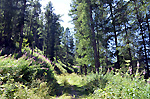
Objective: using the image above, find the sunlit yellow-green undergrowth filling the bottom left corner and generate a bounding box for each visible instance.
[0,80,51,99]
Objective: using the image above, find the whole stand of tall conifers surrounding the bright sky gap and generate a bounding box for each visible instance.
[0,0,150,74]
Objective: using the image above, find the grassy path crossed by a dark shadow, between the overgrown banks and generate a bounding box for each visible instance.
[55,74,88,99]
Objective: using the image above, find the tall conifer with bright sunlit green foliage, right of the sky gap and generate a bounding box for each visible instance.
[70,0,100,72]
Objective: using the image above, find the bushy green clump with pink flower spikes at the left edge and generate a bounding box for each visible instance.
[0,56,34,84]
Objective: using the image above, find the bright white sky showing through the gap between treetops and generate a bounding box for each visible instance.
[40,0,73,31]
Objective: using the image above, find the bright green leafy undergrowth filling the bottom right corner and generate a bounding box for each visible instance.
[89,72,150,99]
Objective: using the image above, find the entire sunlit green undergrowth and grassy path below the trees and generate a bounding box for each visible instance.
[0,49,150,99]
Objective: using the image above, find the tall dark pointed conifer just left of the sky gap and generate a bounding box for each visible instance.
[45,2,60,61]
